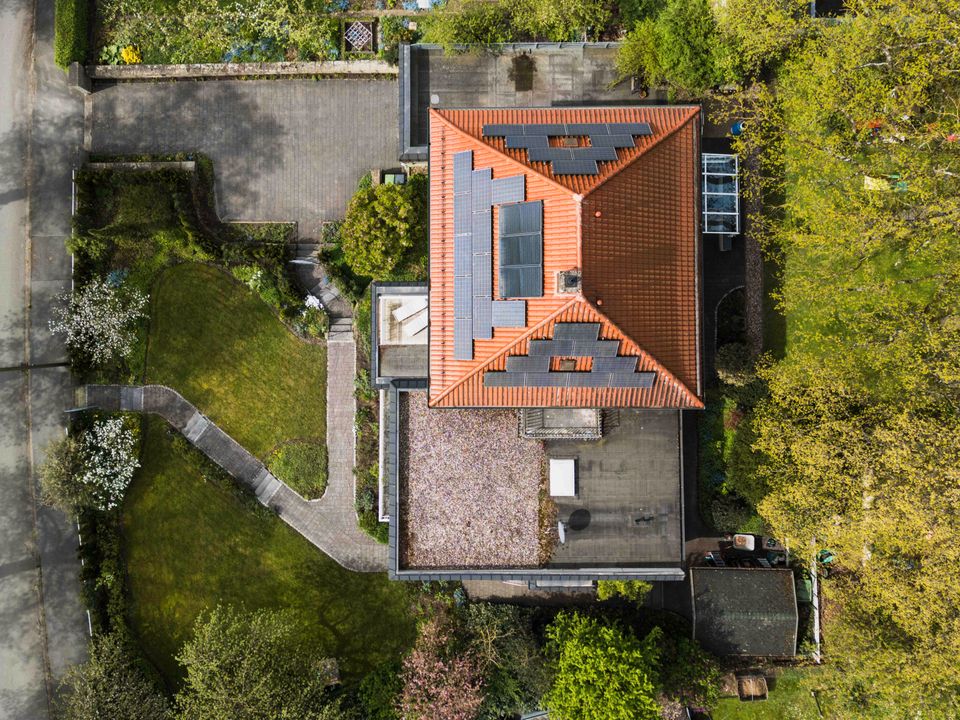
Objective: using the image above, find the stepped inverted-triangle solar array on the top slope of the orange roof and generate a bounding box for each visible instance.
[483,123,653,175]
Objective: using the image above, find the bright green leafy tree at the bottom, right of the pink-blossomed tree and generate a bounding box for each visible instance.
[544,612,660,720]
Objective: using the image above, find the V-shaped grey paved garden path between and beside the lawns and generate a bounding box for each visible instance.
[80,386,387,572]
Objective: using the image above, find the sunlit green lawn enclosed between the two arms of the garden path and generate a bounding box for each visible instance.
[147,263,327,460]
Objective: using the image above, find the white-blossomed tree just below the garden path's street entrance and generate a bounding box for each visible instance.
[77,418,140,510]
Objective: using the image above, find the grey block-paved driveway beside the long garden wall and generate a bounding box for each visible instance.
[88,79,399,237]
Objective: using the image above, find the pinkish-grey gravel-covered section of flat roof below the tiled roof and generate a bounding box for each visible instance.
[400,393,544,568]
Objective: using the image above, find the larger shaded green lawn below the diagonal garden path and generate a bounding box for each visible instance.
[123,418,414,686]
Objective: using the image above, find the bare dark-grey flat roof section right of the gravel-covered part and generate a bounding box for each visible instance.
[545,409,683,567]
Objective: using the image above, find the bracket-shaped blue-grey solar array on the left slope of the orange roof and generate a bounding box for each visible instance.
[453,150,542,360]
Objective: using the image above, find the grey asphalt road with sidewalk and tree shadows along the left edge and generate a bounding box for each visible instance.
[0,0,87,720]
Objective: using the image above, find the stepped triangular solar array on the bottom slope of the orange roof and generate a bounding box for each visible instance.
[483,323,657,388]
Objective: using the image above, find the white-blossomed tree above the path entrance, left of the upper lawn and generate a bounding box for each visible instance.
[50,278,147,365]
